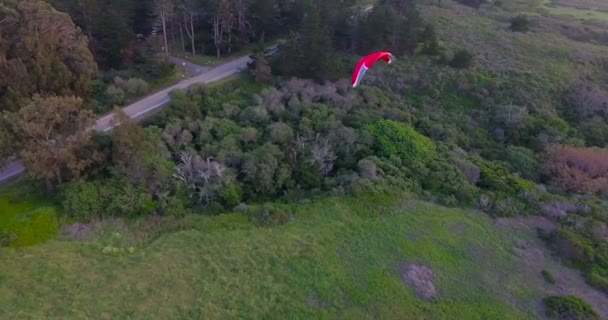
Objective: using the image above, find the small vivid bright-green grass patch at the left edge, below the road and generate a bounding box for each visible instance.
[0,181,59,247]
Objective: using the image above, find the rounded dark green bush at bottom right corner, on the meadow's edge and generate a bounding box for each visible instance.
[543,296,600,320]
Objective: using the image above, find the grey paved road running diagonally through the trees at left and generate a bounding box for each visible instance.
[0,45,276,184]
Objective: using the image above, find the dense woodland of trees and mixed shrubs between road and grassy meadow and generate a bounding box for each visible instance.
[0,0,608,316]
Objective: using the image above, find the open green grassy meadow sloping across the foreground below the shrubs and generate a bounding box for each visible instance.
[0,192,542,320]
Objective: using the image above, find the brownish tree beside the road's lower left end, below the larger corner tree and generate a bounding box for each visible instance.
[3,95,99,191]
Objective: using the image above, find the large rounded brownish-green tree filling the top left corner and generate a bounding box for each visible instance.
[0,0,97,111]
